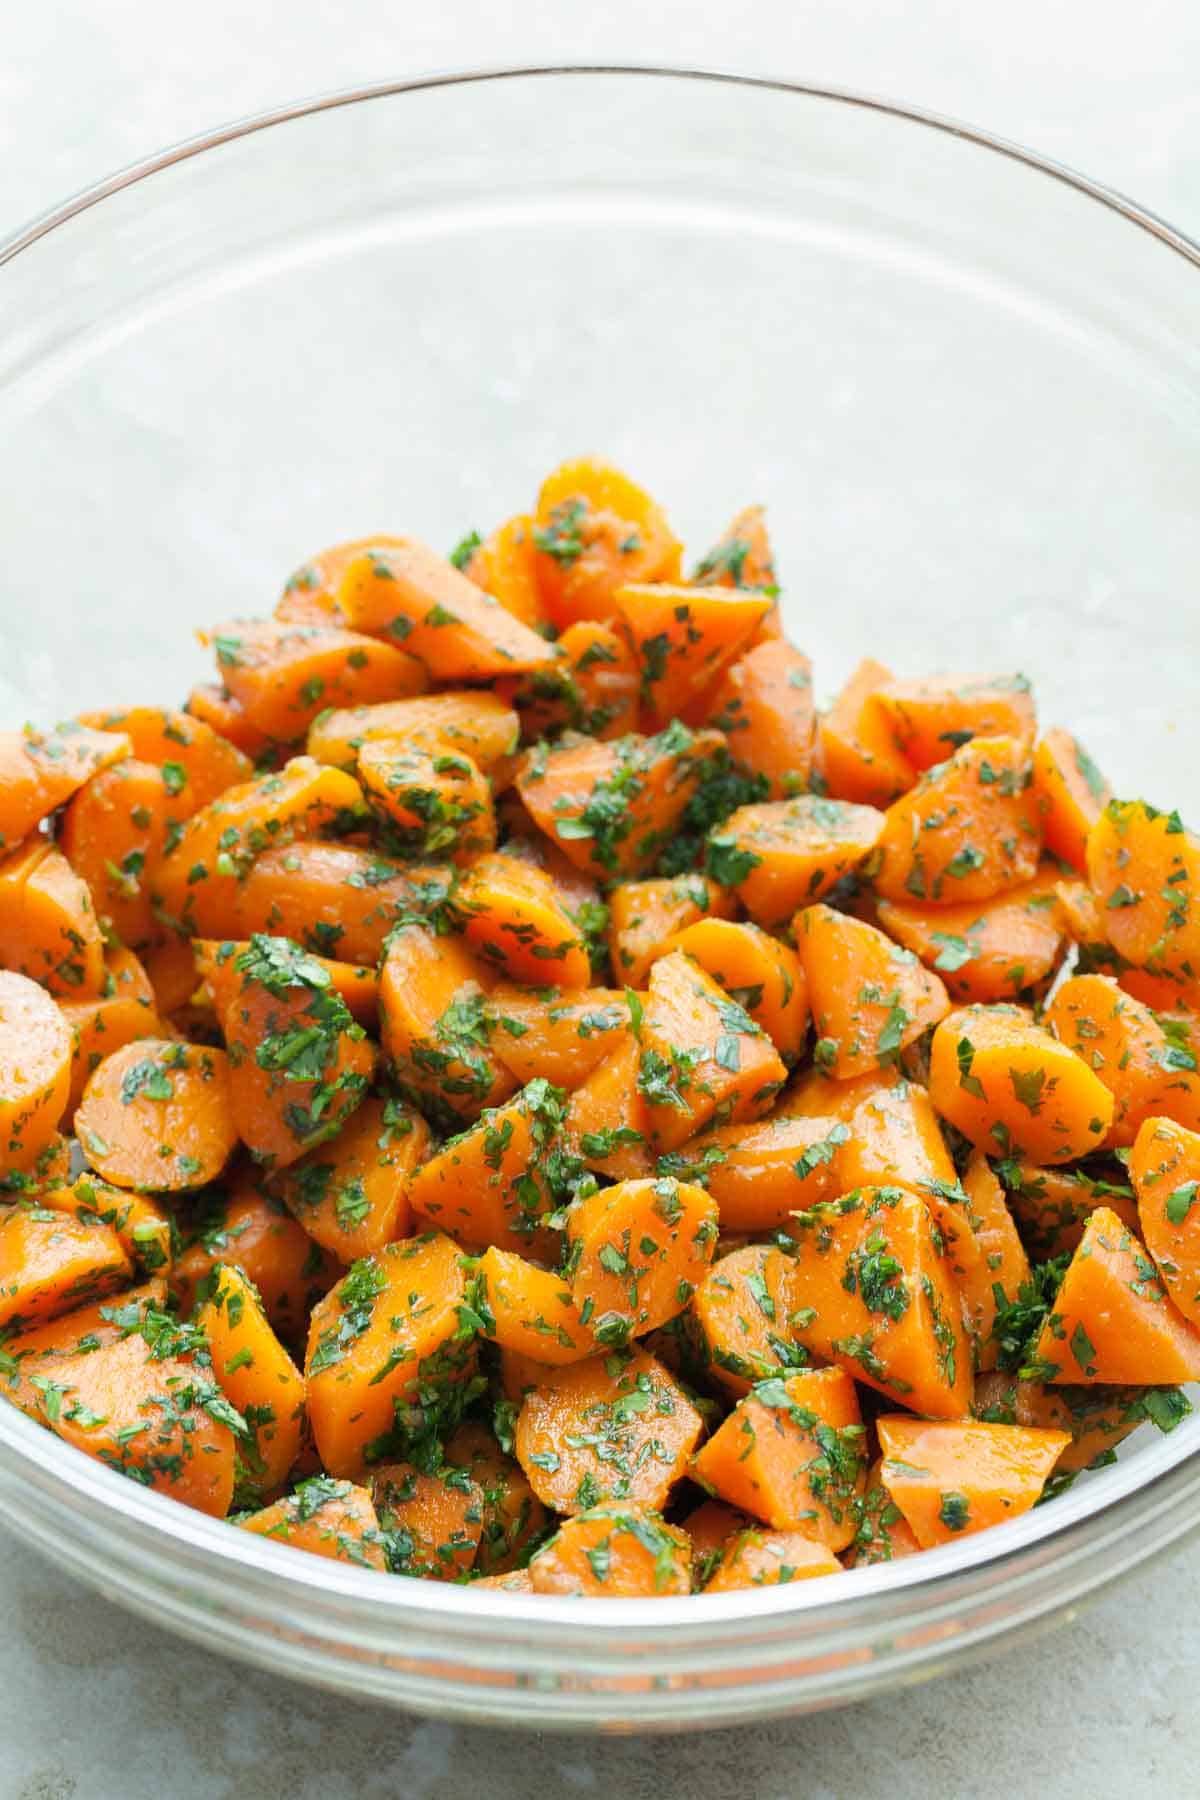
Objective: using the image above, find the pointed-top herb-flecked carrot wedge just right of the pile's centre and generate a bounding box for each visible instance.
[637,950,788,1150]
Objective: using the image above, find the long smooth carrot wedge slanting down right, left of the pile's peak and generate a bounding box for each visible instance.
[338,538,554,676]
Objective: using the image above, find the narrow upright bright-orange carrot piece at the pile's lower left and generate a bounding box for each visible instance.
[196,1264,304,1494]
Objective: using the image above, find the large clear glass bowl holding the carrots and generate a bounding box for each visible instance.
[0,68,1200,1730]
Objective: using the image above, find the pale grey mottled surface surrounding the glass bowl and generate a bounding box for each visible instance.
[0,0,1200,1800]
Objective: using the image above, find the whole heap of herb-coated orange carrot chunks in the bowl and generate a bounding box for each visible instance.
[0,461,1200,1597]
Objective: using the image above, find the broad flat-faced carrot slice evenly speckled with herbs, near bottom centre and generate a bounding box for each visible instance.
[516,1348,702,1514]
